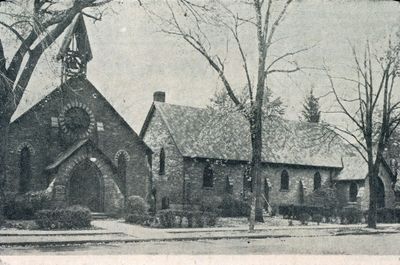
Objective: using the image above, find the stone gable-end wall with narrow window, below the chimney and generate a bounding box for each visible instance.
[143,109,184,209]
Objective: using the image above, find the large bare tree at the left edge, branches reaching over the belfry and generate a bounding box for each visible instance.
[0,0,112,206]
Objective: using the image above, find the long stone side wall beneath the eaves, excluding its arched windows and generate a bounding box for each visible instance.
[181,159,331,206]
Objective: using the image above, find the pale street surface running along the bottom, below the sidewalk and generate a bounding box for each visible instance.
[0,234,400,255]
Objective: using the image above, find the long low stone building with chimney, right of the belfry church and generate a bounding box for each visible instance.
[140,92,396,210]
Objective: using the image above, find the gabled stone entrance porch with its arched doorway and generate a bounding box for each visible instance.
[47,140,124,214]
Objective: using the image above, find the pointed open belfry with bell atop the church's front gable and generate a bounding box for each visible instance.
[57,14,93,83]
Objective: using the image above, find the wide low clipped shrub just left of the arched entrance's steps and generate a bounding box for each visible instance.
[35,205,91,229]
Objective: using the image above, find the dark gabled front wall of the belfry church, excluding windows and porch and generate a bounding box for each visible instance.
[7,79,150,203]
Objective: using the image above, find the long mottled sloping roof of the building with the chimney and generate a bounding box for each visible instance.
[140,102,344,168]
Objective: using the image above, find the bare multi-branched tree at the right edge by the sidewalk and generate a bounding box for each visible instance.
[326,41,400,228]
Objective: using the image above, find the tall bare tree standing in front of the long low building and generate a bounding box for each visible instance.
[149,0,310,231]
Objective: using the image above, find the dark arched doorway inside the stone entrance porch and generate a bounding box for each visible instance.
[68,160,104,212]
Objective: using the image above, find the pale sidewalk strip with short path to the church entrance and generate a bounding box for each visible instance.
[0,219,400,246]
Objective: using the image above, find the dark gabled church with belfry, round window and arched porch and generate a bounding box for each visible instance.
[6,15,152,213]
